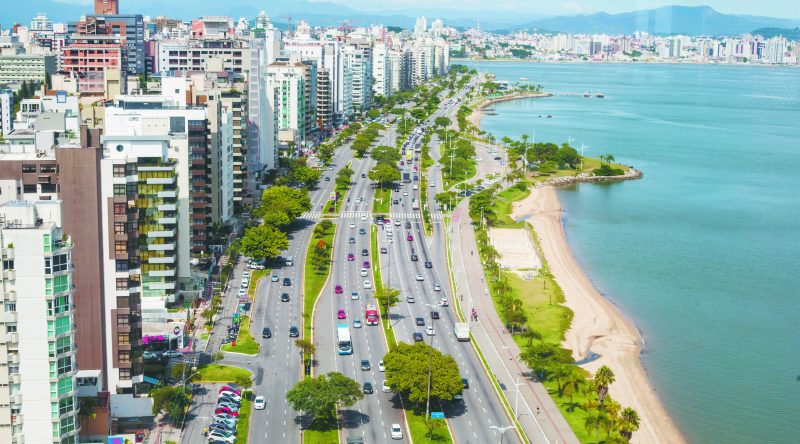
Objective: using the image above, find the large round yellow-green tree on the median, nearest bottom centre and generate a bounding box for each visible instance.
[383,342,464,405]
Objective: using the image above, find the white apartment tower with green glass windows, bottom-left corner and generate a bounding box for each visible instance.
[0,200,80,444]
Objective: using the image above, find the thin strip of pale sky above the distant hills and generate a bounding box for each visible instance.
[306,0,800,19]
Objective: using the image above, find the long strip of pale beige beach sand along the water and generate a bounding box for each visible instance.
[512,186,686,444]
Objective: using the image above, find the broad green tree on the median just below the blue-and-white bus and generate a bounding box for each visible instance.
[286,372,364,422]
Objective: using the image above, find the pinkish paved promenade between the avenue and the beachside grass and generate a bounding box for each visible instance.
[450,199,579,444]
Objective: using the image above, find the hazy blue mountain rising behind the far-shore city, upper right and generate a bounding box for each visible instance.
[518,6,800,35]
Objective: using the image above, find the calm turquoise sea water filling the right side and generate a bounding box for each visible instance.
[467,62,800,443]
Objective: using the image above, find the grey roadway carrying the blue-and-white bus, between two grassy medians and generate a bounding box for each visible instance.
[313,123,405,443]
